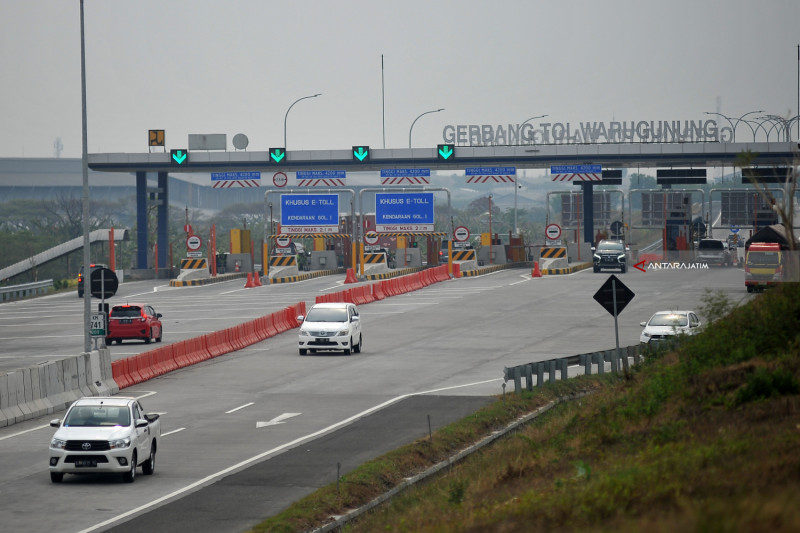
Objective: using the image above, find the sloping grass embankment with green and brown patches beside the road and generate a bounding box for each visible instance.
[254,284,800,532]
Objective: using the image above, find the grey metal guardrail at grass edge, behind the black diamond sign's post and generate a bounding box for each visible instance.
[503,344,641,392]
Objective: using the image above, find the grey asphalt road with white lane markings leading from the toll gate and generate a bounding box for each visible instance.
[0,268,752,532]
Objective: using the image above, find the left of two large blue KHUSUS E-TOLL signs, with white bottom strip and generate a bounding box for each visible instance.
[281,194,339,234]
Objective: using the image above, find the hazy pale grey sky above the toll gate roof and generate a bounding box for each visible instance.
[0,0,800,157]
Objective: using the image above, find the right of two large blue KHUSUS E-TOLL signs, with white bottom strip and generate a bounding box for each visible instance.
[375,192,434,232]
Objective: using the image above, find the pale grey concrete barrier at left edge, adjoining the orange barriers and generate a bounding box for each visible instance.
[0,348,119,426]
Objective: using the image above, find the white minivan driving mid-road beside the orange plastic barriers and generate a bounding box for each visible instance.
[297,302,362,355]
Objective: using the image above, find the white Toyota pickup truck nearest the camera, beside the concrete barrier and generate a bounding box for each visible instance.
[49,396,161,483]
